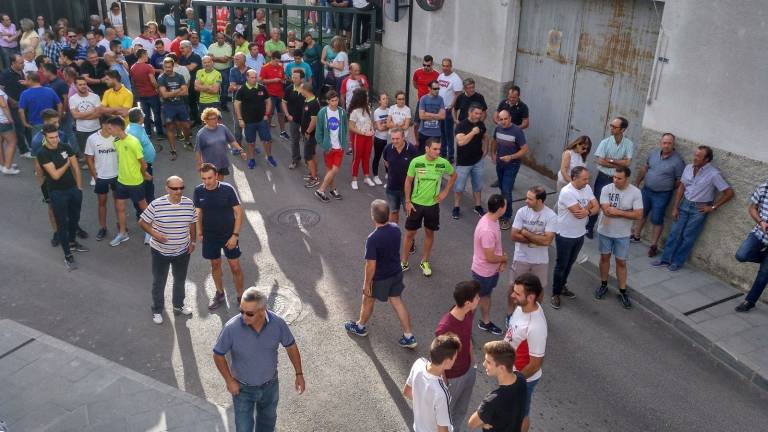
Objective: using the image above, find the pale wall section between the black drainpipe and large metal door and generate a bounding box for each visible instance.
[383,0,520,82]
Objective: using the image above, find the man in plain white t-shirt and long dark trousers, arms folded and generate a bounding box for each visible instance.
[550,166,600,309]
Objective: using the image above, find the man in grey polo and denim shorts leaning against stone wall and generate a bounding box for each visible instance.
[631,133,685,258]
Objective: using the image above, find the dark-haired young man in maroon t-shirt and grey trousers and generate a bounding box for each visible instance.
[435,281,480,431]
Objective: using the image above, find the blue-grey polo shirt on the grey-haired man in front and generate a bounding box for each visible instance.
[213,310,296,386]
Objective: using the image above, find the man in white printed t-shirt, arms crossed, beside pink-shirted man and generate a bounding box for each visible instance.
[507,186,557,319]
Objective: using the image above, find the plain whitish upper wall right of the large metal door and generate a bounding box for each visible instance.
[643,0,768,162]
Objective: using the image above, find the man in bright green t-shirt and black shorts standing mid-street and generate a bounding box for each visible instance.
[400,138,456,277]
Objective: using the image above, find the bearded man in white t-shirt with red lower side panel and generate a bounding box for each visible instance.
[504,273,547,432]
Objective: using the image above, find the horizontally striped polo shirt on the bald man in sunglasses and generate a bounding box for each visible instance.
[141,195,197,256]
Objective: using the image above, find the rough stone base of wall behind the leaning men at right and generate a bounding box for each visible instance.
[633,128,768,299]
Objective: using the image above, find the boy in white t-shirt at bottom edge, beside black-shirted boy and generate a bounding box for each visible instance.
[403,334,461,432]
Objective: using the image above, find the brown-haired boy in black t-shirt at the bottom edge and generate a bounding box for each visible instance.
[469,340,528,432]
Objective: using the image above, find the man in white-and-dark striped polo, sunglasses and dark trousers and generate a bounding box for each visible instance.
[139,176,197,324]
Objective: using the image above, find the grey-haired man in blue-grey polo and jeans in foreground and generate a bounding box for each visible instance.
[213,287,304,432]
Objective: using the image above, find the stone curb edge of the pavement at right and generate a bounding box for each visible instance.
[582,260,768,393]
